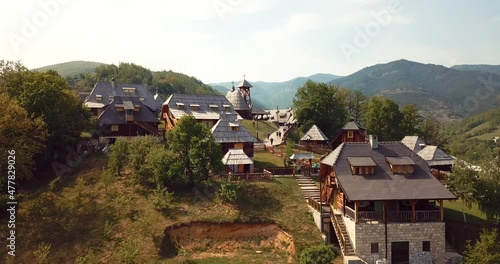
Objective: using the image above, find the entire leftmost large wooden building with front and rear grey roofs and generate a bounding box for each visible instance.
[84,81,161,140]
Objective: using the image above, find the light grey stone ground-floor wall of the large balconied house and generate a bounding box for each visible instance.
[353,222,445,264]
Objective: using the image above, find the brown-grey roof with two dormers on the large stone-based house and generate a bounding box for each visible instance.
[321,142,456,201]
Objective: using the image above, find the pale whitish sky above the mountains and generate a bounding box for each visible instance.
[0,0,500,83]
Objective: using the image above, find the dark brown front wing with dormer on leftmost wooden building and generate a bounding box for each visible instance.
[97,96,160,139]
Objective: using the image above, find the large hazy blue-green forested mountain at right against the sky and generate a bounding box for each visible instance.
[331,60,500,120]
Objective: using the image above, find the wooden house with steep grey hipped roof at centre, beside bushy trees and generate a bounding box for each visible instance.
[211,114,257,173]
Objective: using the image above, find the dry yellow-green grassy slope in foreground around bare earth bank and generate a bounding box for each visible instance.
[4,156,332,263]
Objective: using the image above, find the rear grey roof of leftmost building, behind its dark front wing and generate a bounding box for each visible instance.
[85,82,161,111]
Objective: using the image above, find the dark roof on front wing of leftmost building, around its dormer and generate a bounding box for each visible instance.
[98,96,160,126]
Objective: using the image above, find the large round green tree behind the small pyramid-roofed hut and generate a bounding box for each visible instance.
[293,80,347,138]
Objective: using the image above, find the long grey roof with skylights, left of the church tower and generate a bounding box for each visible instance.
[163,94,242,120]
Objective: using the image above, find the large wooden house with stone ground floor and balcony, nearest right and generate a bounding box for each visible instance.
[320,137,456,264]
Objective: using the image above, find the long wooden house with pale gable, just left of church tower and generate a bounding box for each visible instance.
[161,94,241,131]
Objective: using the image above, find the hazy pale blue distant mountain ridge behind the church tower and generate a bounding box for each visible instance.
[209,73,340,109]
